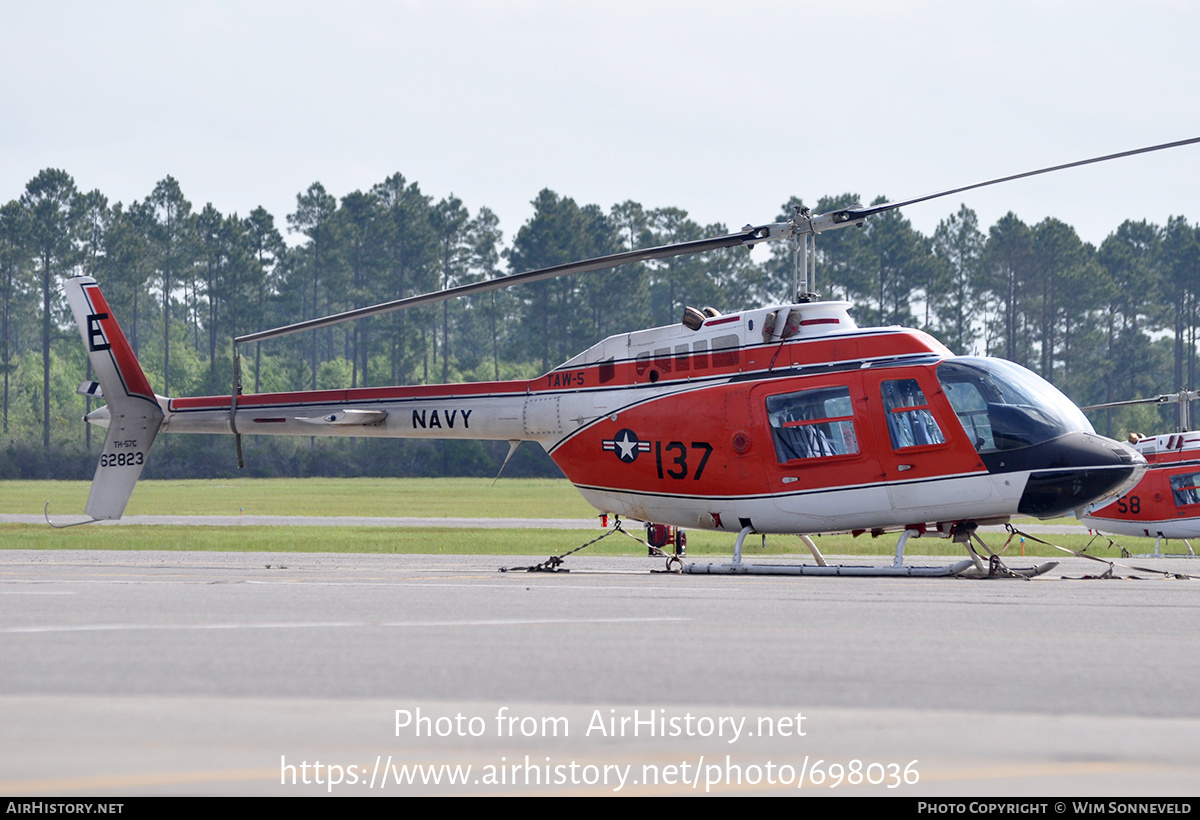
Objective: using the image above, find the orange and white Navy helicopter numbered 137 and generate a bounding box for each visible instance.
[56,138,1200,574]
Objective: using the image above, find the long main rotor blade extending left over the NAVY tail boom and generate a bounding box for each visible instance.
[233,225,772,345]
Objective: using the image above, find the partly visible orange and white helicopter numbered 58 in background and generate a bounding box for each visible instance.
[1080,390,1200,557]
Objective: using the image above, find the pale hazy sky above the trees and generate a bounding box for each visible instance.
[0,0,1200,256]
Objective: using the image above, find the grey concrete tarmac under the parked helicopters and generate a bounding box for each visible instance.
[0,550,1200,797]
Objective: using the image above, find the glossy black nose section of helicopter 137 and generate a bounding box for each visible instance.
[982,432,1146,519]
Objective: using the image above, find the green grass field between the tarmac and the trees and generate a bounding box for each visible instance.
[0,478,1113,557]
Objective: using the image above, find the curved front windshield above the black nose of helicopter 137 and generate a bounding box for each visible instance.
[937,357,1094,453]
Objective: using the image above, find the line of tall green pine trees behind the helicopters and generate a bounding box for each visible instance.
[0,168,1200,477]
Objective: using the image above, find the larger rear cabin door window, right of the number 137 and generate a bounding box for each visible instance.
[767,387,858,463]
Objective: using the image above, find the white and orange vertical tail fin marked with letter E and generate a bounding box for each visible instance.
[62,276,163,520]
